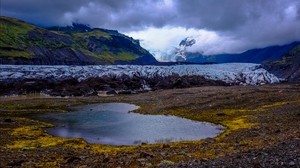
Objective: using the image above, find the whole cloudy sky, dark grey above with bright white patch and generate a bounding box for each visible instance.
[0,0,300,61]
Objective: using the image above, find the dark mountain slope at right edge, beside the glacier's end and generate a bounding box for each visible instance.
[263,45,300,82]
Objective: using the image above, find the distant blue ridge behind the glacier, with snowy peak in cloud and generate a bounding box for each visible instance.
[175,37,300,64]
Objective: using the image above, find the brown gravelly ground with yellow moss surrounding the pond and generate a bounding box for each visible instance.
[0,84,300,167]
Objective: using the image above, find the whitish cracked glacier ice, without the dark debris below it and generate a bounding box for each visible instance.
[0,63,280,85]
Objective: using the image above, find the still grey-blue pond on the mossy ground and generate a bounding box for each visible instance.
[36,103,222,145]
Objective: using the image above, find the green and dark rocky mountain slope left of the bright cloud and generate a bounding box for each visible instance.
[0,16,157,65]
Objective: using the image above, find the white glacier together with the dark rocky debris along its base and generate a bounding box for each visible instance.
[0,63,280,96]
